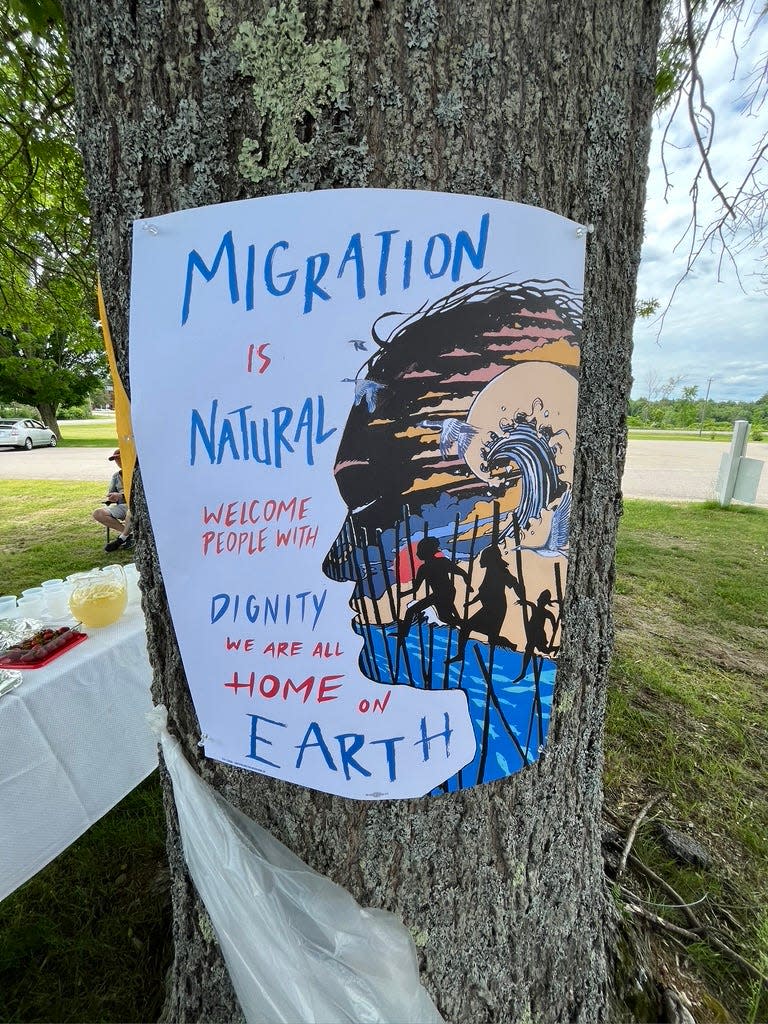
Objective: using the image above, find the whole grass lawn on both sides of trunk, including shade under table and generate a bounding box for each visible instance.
[0,481,768,1024]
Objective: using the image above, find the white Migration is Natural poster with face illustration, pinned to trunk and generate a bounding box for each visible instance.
[130,189,585,800]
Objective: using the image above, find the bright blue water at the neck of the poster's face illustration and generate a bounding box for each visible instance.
[354,621,557,796]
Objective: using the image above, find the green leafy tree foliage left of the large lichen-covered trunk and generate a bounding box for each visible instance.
[0,0,105,433]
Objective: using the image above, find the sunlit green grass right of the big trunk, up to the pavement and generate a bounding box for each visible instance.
[605,502,768,1024]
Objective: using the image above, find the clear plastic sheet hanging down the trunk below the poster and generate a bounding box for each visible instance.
[147,707,442,1024]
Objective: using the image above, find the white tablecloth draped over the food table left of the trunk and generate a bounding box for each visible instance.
[0,604,158,899]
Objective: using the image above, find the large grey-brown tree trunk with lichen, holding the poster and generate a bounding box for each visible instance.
[65,0,662,1024]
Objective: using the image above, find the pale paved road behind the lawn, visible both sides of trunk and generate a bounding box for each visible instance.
[0,440,768,508]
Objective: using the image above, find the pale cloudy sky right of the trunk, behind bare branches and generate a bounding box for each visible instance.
[632,12,768,401]
